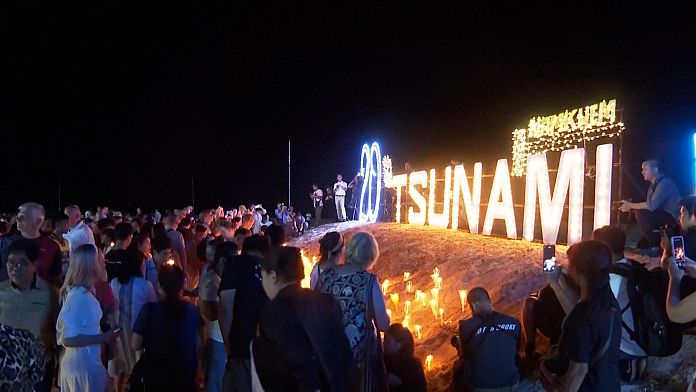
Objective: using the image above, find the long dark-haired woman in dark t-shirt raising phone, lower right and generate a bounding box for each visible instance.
[541,241,621,391]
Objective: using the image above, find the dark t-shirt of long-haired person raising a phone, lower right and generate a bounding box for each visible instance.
[558,284,621,391]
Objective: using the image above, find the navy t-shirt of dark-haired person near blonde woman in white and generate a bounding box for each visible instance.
[133,301,200,391]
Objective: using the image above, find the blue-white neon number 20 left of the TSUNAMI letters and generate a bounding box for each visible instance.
[358,142,382,223]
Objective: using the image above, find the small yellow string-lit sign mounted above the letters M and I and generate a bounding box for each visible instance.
[511,99,625,177]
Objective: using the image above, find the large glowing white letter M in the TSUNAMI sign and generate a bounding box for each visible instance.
[523,148,585,245]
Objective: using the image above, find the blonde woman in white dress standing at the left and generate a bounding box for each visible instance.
[56,244,119,392]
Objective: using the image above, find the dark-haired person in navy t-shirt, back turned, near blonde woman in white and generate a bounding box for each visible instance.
[131,265,200,391]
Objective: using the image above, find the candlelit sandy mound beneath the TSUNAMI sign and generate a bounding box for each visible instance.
[289,222,696,391]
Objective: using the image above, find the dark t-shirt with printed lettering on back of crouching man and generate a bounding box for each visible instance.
[459,312,521,388]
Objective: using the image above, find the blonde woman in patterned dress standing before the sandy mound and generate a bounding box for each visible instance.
[320,232,390,391]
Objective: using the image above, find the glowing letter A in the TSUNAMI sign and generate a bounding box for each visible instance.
[482,159,517,238]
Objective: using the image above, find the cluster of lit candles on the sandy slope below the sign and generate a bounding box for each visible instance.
[382,267,467,370]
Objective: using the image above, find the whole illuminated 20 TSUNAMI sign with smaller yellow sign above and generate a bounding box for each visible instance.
[368,100,624,245]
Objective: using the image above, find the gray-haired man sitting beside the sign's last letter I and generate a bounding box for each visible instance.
[620,159,681,256]
